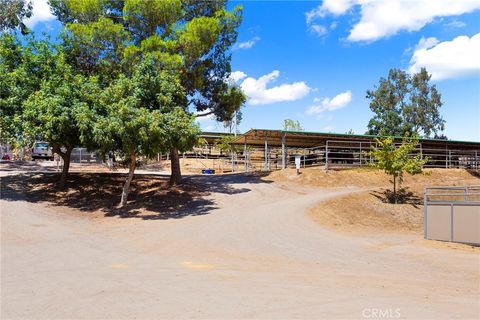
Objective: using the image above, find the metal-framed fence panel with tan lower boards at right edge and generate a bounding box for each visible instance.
[424,186,480,245]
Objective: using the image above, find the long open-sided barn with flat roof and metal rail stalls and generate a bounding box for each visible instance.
[193,129,480,171]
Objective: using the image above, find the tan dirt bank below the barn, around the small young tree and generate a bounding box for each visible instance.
[269,168,480,233]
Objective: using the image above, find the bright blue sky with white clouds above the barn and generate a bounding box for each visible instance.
[30,0,480,141]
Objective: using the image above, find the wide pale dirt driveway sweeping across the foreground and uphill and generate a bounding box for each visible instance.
[0,177,480,319]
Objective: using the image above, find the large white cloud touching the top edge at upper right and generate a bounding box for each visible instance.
[306,0,480,42]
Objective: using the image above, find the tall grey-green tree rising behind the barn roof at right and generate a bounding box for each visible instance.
[366,68,445,137]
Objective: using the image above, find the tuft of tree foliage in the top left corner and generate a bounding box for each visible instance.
[0,0,33,35]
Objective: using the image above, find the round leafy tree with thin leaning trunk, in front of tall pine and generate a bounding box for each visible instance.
[80,59,200,207]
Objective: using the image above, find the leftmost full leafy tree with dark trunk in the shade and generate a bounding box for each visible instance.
[22,53,99,188]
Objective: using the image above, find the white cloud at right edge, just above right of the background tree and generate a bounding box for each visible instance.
[408,33,480,80]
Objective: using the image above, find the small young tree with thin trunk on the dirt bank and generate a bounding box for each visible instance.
[369,136,428,203]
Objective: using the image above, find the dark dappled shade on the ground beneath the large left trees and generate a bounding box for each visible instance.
[0,172,270,220]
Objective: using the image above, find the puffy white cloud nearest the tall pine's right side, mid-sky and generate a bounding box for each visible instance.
[240,70,311,105]
